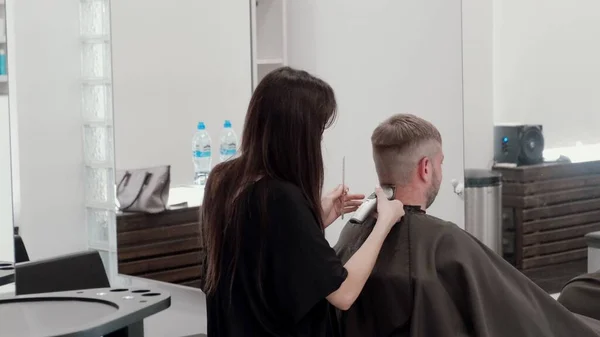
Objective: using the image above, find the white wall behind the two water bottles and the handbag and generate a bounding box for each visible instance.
[111,0,252,185]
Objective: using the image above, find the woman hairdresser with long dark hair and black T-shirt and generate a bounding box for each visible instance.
[202,67,404,337]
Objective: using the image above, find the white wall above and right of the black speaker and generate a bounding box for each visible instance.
[494,0,600,148]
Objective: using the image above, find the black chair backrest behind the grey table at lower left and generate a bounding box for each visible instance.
[15,250,110,295]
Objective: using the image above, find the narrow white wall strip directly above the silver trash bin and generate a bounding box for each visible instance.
[462,0,494,169]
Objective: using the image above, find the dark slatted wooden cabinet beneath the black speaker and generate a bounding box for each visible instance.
[494,161,600,292]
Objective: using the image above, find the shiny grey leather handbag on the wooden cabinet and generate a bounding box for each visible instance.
[116,165,171,214]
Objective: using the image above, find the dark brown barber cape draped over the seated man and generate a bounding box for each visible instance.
[335,207,600,337]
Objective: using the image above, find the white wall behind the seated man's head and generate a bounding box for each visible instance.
[288,0,464,243]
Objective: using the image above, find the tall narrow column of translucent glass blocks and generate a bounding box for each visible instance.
[79,0,117,283]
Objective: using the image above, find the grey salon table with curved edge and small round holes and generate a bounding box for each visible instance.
[0,288,171,337]
